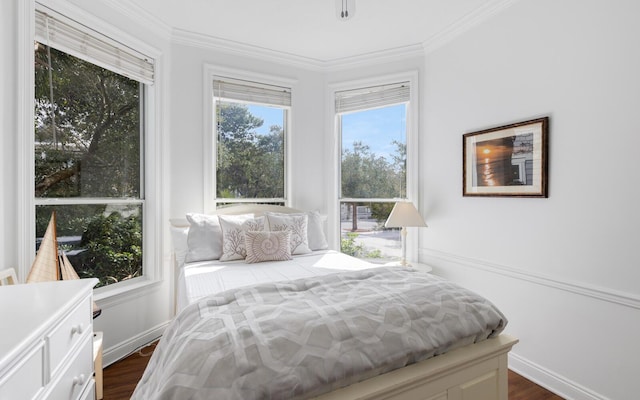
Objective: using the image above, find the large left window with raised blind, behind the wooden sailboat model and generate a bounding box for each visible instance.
[33,7,154,286]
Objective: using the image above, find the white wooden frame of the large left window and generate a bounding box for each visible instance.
[17,0,163,304]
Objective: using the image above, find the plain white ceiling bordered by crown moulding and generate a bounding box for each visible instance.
[111,0,514,63]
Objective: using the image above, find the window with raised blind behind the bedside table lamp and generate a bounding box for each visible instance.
[335,82,410,263]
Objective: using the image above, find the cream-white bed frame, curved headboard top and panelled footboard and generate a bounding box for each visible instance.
[171,204,518,400]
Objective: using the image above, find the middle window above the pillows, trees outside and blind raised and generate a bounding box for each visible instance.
[213,77,291,206]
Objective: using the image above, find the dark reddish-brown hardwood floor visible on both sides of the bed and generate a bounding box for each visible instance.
[104,344,562,400]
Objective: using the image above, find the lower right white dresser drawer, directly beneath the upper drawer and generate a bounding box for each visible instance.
[47,335,94,400]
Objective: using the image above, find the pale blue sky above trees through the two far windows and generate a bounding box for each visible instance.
[248,104,407,162]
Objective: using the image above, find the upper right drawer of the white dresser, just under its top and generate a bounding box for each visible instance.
[47,298,92,377]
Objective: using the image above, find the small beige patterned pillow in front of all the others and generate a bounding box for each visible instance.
[244,231,291,263]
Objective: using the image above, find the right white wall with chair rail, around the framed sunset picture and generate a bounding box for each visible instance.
[421,0,640,399]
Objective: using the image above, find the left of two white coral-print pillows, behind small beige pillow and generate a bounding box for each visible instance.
[218,214,265,261]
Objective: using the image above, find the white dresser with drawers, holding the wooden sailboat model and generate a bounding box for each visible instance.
[0,279,98,400]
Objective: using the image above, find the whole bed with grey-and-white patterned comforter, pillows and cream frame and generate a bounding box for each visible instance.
[132,205,517,400]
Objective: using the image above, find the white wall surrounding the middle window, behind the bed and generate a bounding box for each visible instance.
[170,42,326,218]
